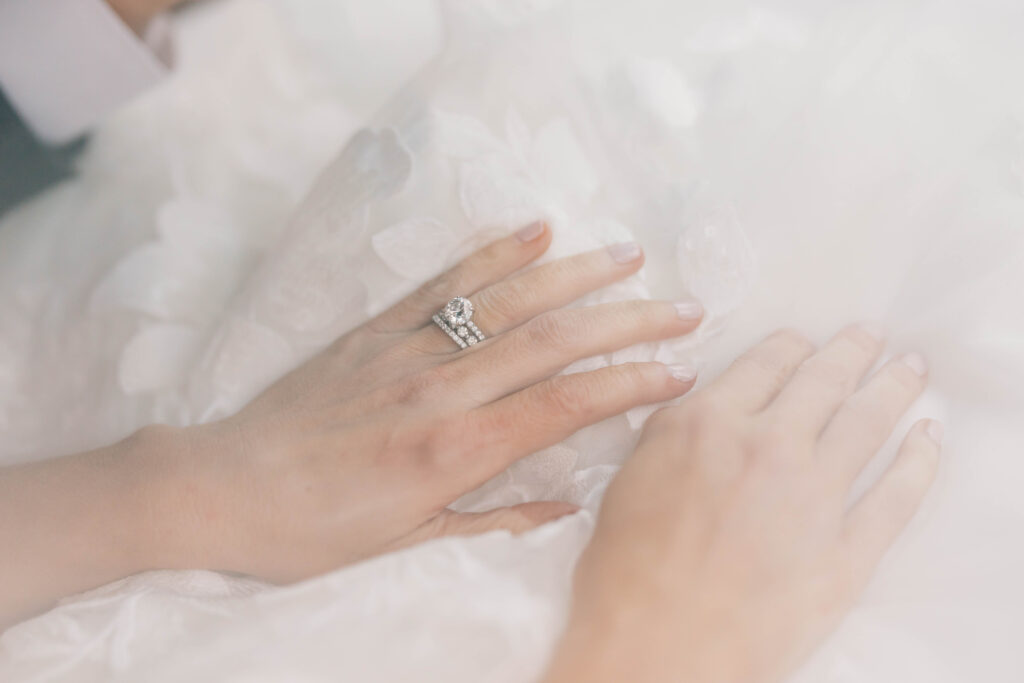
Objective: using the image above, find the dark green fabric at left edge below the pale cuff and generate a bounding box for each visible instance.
[0,90,84,215]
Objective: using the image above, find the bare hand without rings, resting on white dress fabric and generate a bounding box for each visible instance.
[548,328,941,683]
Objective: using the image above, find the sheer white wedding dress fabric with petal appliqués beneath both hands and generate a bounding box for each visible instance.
[0,0,1024,683]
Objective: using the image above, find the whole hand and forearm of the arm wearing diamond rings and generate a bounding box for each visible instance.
[0,223,701,624]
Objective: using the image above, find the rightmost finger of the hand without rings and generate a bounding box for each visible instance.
[846,420,942,581]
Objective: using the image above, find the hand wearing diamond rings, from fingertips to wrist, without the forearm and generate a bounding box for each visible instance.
[152,224,701,581]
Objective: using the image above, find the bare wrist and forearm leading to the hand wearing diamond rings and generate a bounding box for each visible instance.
[0,428,197,629]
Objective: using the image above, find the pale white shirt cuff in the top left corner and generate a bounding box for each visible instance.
[0,0,169,144]
